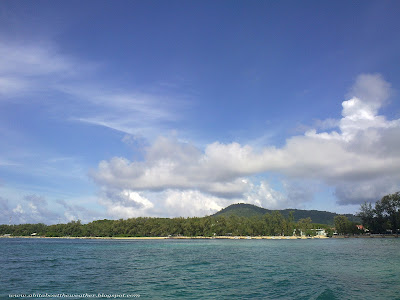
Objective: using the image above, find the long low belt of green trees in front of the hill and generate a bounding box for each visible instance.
[0,211,332,237]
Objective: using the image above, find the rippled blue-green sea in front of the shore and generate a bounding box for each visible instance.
[0,238,400,299]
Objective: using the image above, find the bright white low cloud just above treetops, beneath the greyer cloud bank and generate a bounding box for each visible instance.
[99,181,290,218]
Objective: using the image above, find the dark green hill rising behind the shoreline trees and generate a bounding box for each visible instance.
[212,203,361,225]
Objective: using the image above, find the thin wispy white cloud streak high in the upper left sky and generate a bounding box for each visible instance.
[0,39,188,138]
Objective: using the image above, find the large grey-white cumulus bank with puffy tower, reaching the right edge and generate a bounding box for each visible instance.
[91,74,400,217]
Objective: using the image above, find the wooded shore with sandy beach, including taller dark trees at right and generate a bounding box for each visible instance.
[0,192,400,239]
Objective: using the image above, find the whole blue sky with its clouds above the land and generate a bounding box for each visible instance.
[0,0,400,224]
